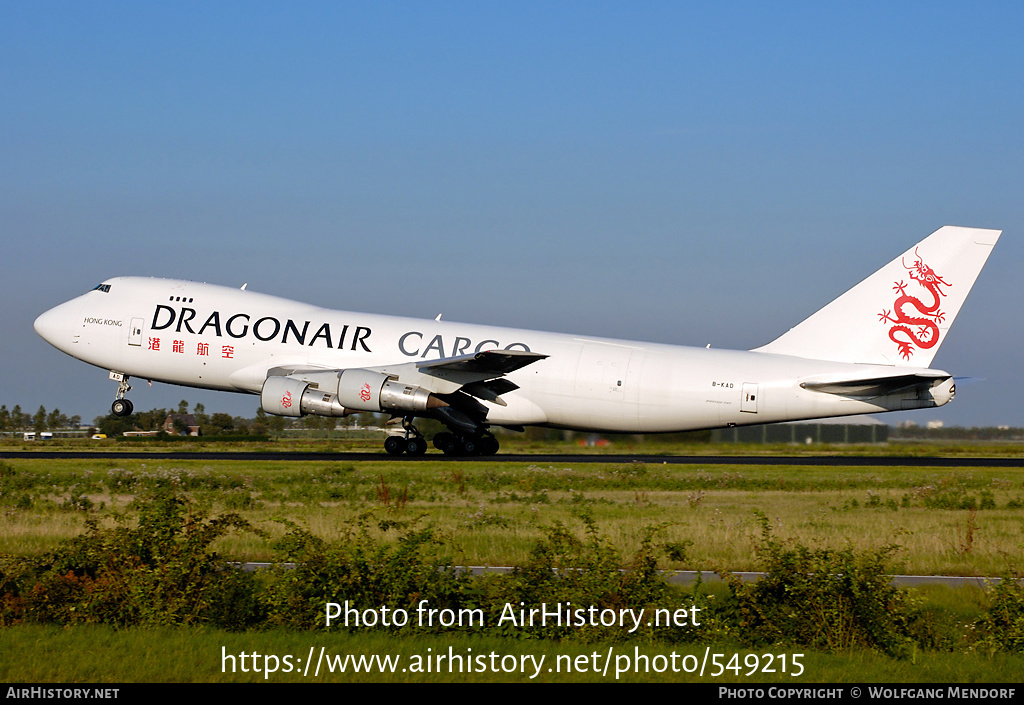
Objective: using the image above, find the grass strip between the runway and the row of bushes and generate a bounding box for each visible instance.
[0,448,1024,576]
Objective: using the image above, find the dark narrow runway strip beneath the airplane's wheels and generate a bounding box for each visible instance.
[0,451,1024,467]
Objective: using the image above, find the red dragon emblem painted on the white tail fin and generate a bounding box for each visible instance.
[879,248,950,360]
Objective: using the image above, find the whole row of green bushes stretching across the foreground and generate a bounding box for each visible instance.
[12,489,1024,657]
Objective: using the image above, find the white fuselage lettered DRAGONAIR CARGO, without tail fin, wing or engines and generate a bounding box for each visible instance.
[36,277,952,432]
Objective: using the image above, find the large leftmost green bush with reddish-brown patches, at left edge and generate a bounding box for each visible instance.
[0,489,261,629]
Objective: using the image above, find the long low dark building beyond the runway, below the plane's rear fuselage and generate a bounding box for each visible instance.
[711,416,889,444]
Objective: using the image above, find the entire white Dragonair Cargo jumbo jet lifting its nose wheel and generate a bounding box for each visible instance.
[35,226,1000,455]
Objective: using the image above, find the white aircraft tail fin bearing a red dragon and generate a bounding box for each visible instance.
[755,225,1001,368]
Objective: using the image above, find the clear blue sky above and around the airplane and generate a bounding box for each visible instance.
[0,1,1024,426]
